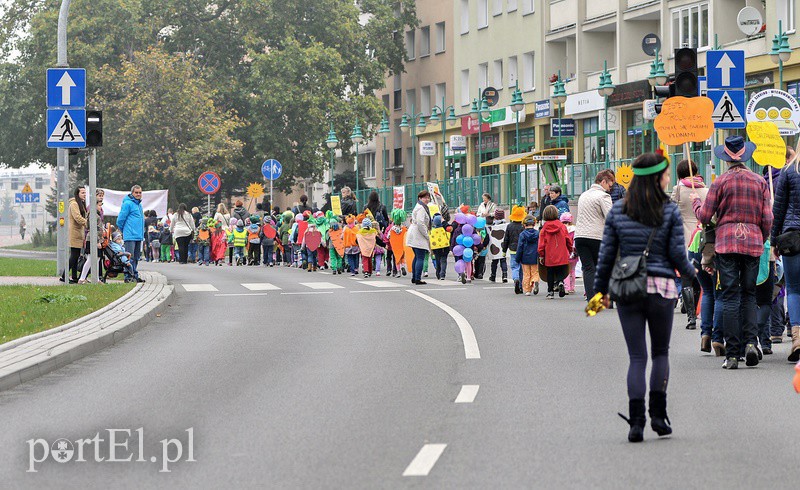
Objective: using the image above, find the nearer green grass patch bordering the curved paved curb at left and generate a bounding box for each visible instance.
[0,284,134,344]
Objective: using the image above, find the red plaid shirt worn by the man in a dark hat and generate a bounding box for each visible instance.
[692,163,772,257]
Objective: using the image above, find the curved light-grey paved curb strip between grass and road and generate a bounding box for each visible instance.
[0,272,175,391]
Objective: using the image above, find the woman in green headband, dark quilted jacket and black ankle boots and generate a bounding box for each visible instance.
[594,153,696,442]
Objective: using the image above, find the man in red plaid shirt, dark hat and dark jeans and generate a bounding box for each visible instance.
[692,136,772,369]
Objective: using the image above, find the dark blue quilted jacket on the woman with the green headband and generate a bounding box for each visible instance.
[594,200,696,294]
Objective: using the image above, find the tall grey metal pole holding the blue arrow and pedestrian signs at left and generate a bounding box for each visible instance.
[56,0,70,284]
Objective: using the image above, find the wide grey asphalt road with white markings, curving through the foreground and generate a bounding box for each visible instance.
[0,258,800,488]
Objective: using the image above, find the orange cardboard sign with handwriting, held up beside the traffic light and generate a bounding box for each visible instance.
[655,97,714,146]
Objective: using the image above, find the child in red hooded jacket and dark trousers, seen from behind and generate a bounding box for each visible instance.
[539,204,573,299]
